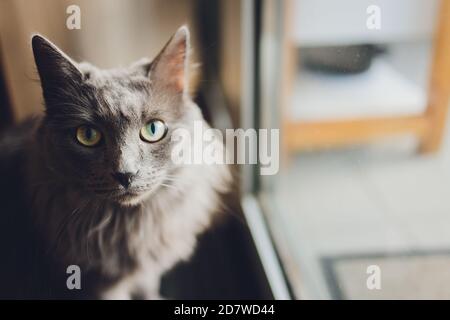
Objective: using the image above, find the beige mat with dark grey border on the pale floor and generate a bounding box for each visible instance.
[322,250,450,300]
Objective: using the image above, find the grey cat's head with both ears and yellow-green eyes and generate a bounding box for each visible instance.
[32,27,200,204]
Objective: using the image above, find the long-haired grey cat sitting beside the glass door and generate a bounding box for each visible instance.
[0,26,231,299]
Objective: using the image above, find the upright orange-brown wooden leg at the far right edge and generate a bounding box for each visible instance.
[420,0,450,153]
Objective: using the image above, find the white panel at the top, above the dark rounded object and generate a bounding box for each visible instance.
[293,0,438,46]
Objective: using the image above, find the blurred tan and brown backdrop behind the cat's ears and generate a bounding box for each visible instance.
[0,0,240,125]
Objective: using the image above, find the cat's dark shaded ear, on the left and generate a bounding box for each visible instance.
[31,35,83,90]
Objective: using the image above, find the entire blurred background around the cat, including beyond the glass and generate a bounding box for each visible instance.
[0,0,450,299]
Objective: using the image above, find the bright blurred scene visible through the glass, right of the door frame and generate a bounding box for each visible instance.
[258,0,450,299]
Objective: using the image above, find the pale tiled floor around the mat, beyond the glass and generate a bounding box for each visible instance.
[269,115,450,298]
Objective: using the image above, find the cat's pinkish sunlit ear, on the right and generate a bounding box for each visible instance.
[149,26,190,94]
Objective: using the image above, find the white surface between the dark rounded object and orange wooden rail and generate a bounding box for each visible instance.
[290,58,427,120]
